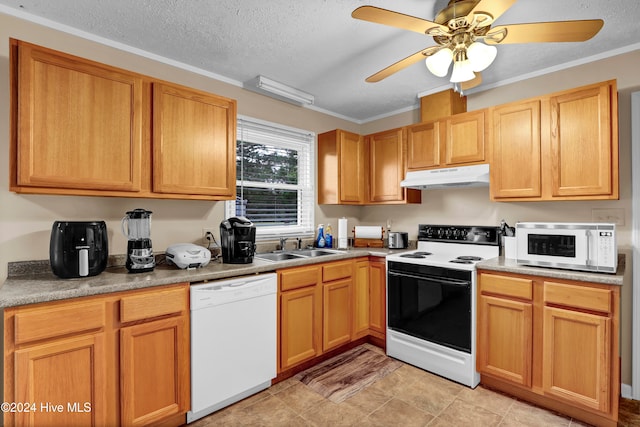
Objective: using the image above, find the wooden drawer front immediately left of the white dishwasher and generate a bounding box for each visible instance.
[120,284,189,323]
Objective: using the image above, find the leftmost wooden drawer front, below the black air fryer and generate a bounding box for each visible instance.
[15,301,106,344]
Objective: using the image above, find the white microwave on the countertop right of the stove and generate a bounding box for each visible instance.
[516,222,618,273]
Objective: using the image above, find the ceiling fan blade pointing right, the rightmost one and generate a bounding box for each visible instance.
[485,19,604,44]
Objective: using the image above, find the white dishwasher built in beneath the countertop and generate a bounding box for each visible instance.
[187,273,278,423]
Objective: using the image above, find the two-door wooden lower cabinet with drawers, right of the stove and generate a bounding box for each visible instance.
[476,270,620,426]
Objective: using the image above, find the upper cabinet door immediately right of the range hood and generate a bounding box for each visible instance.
[491,100,542,199]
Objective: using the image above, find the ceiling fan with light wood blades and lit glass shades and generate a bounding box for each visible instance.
[351,0,604,90]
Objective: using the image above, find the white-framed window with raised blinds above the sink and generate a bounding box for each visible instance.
[226,116,315,239]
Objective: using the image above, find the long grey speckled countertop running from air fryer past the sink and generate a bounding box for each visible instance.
[0,248,398,307]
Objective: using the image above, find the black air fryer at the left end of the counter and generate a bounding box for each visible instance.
[49,221,109,279]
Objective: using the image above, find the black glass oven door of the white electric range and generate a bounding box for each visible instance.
[387,262,472,353]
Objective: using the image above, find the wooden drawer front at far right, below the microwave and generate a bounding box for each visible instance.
[544,282,612,313]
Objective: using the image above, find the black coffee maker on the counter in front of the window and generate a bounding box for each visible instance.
[220,216,256,264]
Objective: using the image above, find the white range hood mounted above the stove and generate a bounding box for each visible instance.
[400,164,489,190]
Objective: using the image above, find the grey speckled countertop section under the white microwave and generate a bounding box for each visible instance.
[476,255,625,286]
